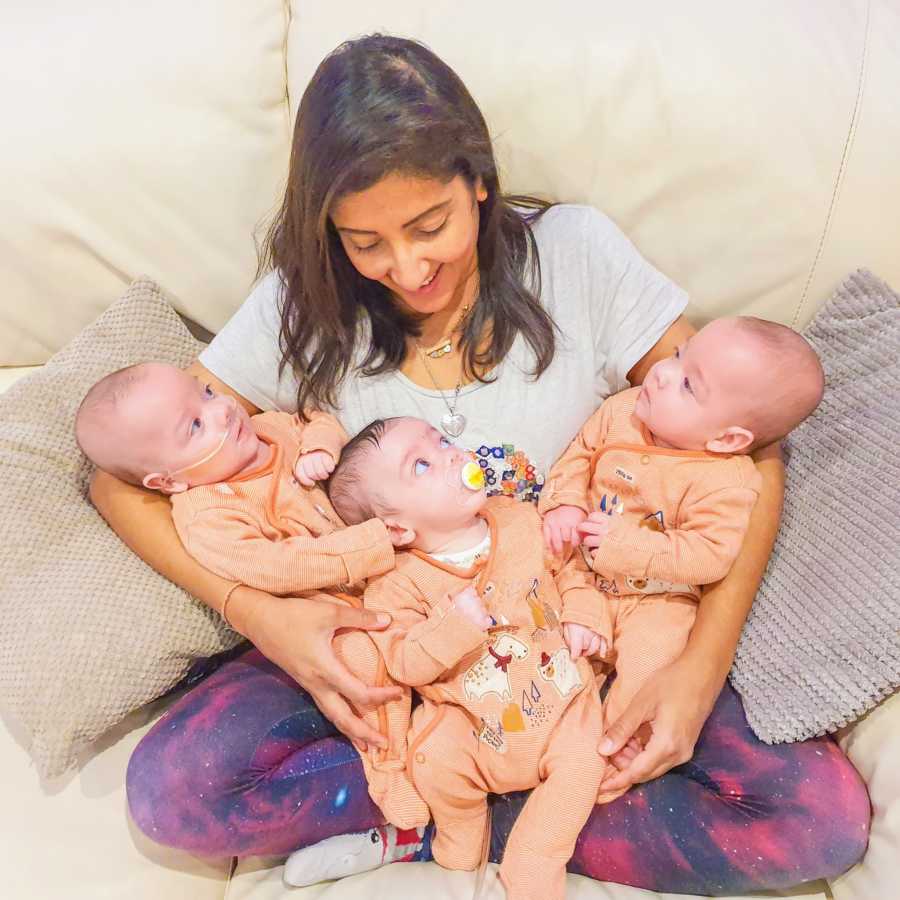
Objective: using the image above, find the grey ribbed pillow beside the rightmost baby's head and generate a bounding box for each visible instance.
[731,271,900,743]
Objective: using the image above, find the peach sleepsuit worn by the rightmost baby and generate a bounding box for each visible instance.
[540,388,760,802]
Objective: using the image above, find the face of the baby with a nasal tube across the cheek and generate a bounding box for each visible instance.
[109,363,259,487]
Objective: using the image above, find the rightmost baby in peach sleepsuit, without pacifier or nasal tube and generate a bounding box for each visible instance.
[539,317,824,802]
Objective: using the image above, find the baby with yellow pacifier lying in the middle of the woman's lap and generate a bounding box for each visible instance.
[300,418,607,900]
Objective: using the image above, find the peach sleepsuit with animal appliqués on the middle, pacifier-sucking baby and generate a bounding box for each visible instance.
[365,497,606,900]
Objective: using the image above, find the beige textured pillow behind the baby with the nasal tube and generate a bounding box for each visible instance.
[0,281,239,777]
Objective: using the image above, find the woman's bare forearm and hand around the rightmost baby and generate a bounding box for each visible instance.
[601,444,784,790]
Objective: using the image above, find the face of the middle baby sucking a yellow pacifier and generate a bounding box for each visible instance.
[364,418,487,544]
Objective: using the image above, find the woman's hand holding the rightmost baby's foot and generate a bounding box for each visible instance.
[600,656,724,791]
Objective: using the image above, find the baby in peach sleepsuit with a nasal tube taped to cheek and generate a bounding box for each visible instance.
[75,363,429,829]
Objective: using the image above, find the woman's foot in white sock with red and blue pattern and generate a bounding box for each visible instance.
[284,825,425,887]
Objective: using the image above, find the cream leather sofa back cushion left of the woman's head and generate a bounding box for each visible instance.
[0,0,290,365]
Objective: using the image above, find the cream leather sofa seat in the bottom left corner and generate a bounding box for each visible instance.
[0,708,231,900]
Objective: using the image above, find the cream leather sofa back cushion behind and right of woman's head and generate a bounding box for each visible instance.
[287,0,900,327]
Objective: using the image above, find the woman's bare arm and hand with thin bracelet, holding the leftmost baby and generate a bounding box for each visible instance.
[90,363,400,742]
